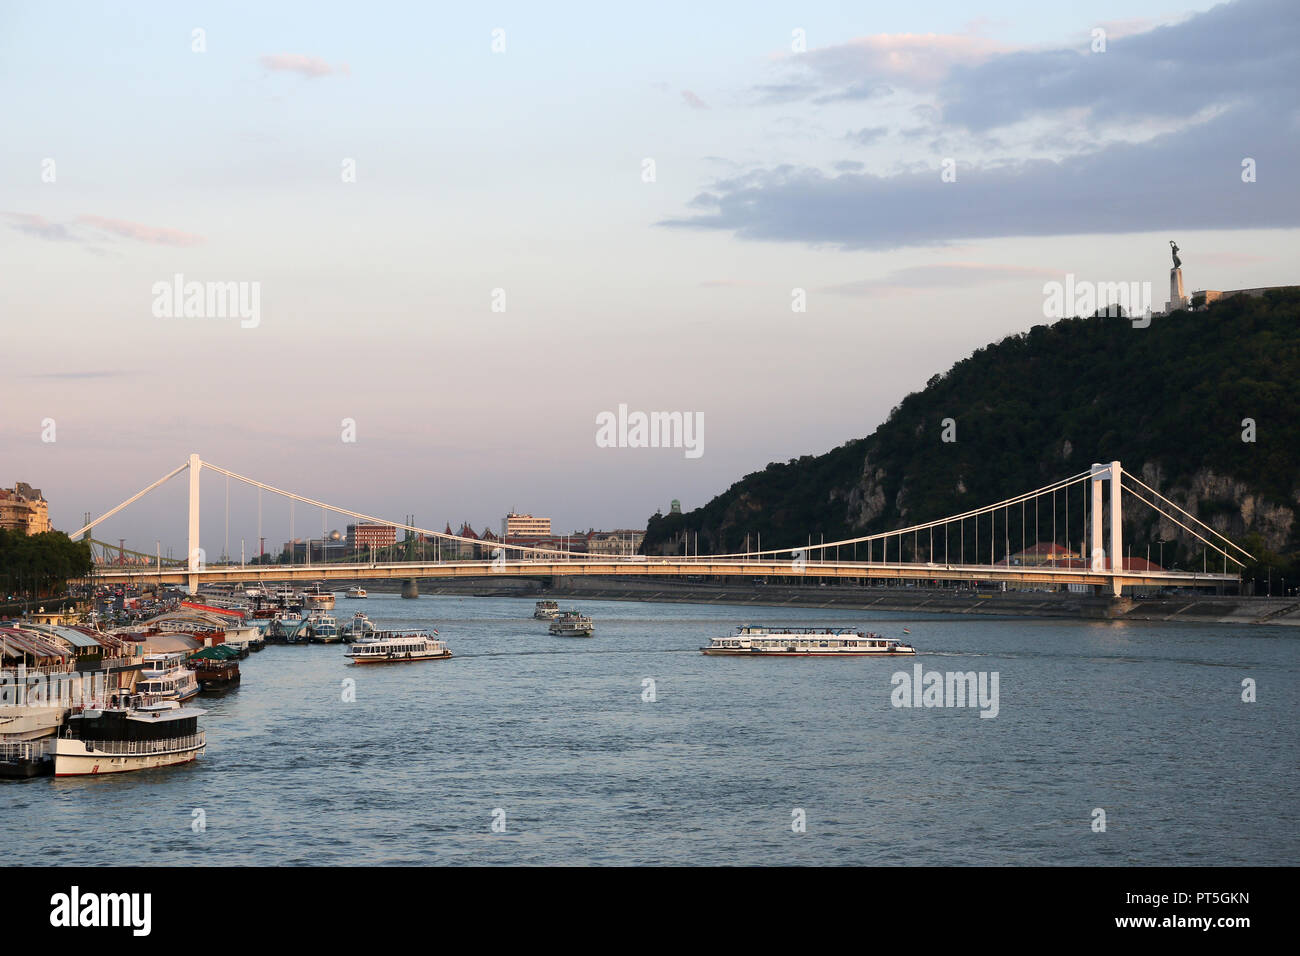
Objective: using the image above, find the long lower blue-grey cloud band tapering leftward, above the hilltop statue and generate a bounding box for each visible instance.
[663,103,1300,248]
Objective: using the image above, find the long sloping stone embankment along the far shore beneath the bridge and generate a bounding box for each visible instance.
[345,576,1300,627]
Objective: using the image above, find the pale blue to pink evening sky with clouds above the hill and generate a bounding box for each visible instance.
[0,0,1300,555]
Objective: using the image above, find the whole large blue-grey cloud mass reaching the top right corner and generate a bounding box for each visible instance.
[662,0,1300,248]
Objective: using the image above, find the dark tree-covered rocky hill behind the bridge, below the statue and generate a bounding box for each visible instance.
[645,290,1300,593]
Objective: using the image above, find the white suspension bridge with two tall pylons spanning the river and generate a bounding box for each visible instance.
[72,454,1251,596]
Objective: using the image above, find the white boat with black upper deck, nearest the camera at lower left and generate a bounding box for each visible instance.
[53,700,207,777]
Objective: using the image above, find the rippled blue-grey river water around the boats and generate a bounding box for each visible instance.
[0,594,1300,865]
